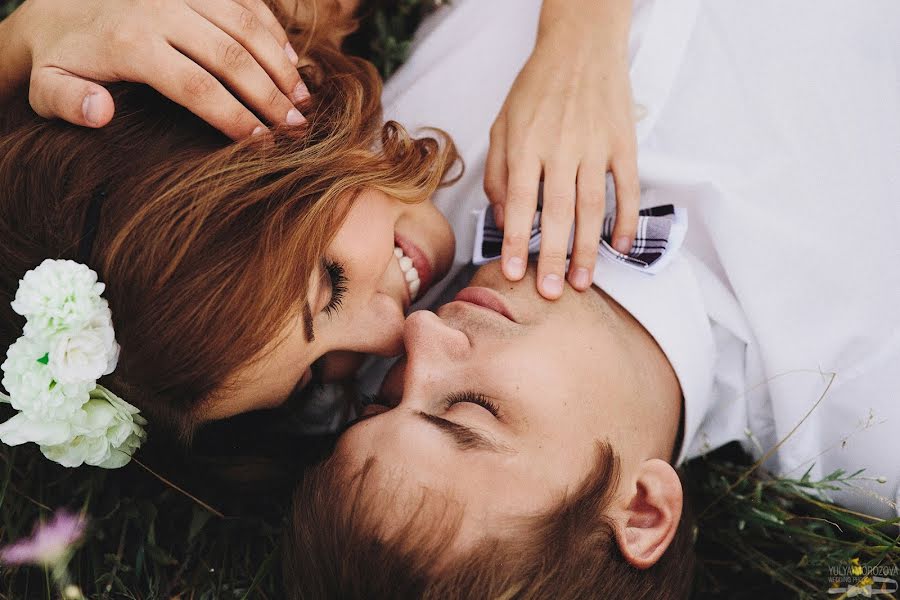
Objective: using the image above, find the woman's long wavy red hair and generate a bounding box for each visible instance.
[0,3,457,440]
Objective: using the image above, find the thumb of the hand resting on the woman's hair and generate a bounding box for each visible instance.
[28,67,115,127]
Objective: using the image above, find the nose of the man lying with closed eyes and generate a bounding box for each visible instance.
[403,310,471,368]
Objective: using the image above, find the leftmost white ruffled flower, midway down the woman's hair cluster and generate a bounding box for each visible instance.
[0,337,90,421]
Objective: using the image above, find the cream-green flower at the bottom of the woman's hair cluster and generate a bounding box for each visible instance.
[41,386,147,469]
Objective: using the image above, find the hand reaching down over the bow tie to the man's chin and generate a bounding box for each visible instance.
[484,0,640,300]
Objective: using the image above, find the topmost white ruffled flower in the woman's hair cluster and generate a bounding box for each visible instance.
[12,259,108,338]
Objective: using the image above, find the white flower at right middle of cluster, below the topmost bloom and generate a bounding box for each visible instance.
[49,309,119,383]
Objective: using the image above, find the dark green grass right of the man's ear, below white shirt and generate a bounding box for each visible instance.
[685,447,900,599]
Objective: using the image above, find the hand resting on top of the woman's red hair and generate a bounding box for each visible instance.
[8,0,309,139]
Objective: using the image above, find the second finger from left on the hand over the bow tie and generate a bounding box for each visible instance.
[537,161,576,300]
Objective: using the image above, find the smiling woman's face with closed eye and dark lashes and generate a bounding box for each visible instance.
[206,190,455,421]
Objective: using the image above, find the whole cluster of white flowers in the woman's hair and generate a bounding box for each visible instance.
[0,259,147,469]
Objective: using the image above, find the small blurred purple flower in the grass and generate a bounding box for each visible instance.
[0,509,86,566]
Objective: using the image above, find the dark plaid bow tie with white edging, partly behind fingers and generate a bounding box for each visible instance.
[472,204,687,275]
